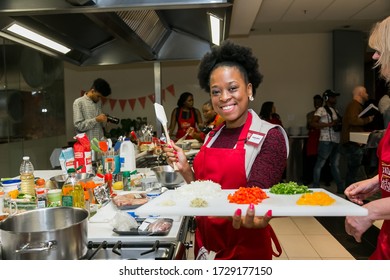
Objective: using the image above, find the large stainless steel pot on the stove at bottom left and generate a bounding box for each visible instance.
[0,207,88,260]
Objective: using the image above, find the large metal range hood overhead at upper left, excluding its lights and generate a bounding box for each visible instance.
[0,0,233,66]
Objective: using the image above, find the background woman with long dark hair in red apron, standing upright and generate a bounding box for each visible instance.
[169,92,203,139]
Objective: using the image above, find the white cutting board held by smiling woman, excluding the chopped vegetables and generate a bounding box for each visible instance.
[134,188,368,217]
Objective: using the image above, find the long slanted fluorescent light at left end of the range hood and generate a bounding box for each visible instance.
[7,23,70,54]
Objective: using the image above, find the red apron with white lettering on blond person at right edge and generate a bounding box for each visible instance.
[370,127,390,260]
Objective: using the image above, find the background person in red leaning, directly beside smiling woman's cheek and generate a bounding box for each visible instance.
[187,100,223,142]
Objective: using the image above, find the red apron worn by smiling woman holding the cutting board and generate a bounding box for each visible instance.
[193,114,281,260]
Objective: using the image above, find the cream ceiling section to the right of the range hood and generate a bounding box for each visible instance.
[229,0,390,37]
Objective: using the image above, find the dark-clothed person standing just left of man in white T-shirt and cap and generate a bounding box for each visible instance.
[303,94,323,185]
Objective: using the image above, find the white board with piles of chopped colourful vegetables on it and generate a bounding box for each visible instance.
[134,181,367,217]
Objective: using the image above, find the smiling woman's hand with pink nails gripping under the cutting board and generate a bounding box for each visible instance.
[232,203,272,229]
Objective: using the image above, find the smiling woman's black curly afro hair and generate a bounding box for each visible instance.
[198,40,263,96]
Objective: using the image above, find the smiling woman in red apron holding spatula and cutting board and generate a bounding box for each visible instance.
[164,41,288,260]
